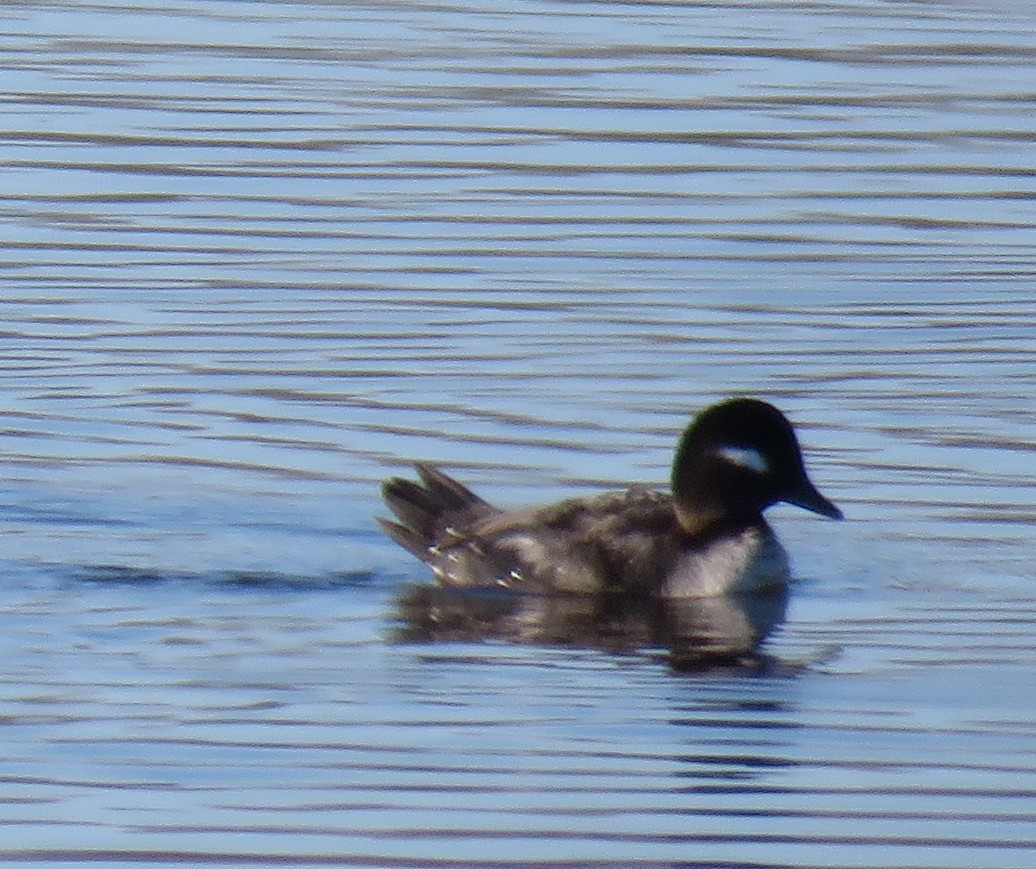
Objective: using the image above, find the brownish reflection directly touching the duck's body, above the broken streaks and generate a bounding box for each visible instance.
[396,584,787,669]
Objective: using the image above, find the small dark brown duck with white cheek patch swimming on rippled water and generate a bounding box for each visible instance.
[378,398,843,600]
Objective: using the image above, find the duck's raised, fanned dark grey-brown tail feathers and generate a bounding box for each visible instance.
[378,462,497,561]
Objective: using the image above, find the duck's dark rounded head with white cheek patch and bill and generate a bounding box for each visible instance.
[672,399,842,535]
